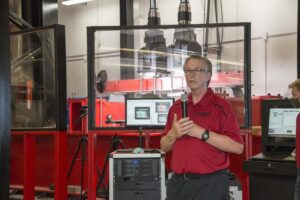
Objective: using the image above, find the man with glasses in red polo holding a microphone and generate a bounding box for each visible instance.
[160,56,244,200]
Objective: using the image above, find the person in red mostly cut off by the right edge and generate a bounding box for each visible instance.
[289,79,300,200]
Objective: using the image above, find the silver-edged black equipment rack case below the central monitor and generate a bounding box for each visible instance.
[109,149,166,200]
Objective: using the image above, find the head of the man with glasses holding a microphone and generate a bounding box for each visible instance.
[183,59,211,90]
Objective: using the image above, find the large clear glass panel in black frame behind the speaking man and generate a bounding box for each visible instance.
[92,26,245,127]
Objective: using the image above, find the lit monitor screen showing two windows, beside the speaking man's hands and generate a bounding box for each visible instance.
[125,98,174,128]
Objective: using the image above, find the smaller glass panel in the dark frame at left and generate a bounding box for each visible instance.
[10,30,57,129]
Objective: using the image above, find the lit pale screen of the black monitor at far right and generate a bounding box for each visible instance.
[268,108,300,137]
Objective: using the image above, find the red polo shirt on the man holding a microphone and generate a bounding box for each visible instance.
[162,88,243,174]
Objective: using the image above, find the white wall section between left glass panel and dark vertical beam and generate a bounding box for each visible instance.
[58,0,119,97]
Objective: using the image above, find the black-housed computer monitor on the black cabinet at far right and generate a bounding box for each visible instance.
[261,99,300,153]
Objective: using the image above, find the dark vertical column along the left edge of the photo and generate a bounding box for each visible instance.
[0,0,11,199]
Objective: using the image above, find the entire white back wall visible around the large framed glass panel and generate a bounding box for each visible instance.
[59,0,298,96]
